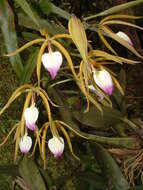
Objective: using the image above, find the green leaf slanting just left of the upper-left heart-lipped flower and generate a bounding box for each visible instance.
[20,48,39,84]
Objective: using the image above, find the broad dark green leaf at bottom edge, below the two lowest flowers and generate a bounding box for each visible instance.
[19,156,46,190]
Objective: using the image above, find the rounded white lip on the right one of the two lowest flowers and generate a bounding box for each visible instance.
[48,136,65,158]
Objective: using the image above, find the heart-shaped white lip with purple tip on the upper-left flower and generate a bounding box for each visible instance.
[42,51,63,79]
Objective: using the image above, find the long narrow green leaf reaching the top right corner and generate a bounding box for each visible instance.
[84,0,143,20]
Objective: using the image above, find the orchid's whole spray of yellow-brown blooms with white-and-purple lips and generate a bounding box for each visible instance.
[0,15,143,168]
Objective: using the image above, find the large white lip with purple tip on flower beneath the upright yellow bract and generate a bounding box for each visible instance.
[93,69,114,96]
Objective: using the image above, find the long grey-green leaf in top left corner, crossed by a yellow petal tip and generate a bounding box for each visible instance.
[0,0,23,78]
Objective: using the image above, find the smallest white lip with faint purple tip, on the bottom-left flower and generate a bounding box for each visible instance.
[19,133,32,154]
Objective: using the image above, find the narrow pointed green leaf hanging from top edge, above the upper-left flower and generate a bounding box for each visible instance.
[15,0,40,27]
